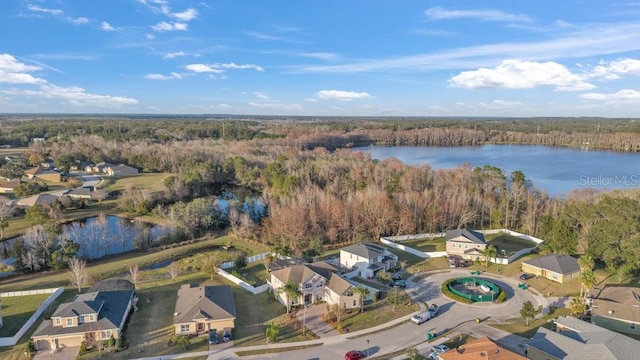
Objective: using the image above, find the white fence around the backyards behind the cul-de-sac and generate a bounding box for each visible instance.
[380,229,544,265]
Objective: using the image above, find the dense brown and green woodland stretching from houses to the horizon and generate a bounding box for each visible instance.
[0,117,640,275]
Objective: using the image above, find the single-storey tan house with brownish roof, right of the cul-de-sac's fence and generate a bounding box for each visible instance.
[522,254,580,284]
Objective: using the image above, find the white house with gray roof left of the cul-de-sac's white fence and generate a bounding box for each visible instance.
[340,243,398,279]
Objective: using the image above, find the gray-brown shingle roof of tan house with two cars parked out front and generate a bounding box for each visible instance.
[173,284,236,324]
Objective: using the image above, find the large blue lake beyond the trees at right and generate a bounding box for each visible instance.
[353,145,640,196]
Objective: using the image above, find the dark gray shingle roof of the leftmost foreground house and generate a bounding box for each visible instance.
[33,290,133,337]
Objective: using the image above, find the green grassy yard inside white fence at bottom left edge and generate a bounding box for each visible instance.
[0,294,51,337]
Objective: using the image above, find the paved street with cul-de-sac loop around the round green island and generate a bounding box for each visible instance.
[130,269,548,360]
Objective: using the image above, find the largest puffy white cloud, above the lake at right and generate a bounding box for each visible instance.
[449,60,595,91]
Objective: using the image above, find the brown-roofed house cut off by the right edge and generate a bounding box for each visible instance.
[589,285,640,335]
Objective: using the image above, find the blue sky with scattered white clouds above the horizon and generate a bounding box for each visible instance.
[0,0,640,117]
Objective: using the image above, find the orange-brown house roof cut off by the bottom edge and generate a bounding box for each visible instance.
[438,336,526,360]
